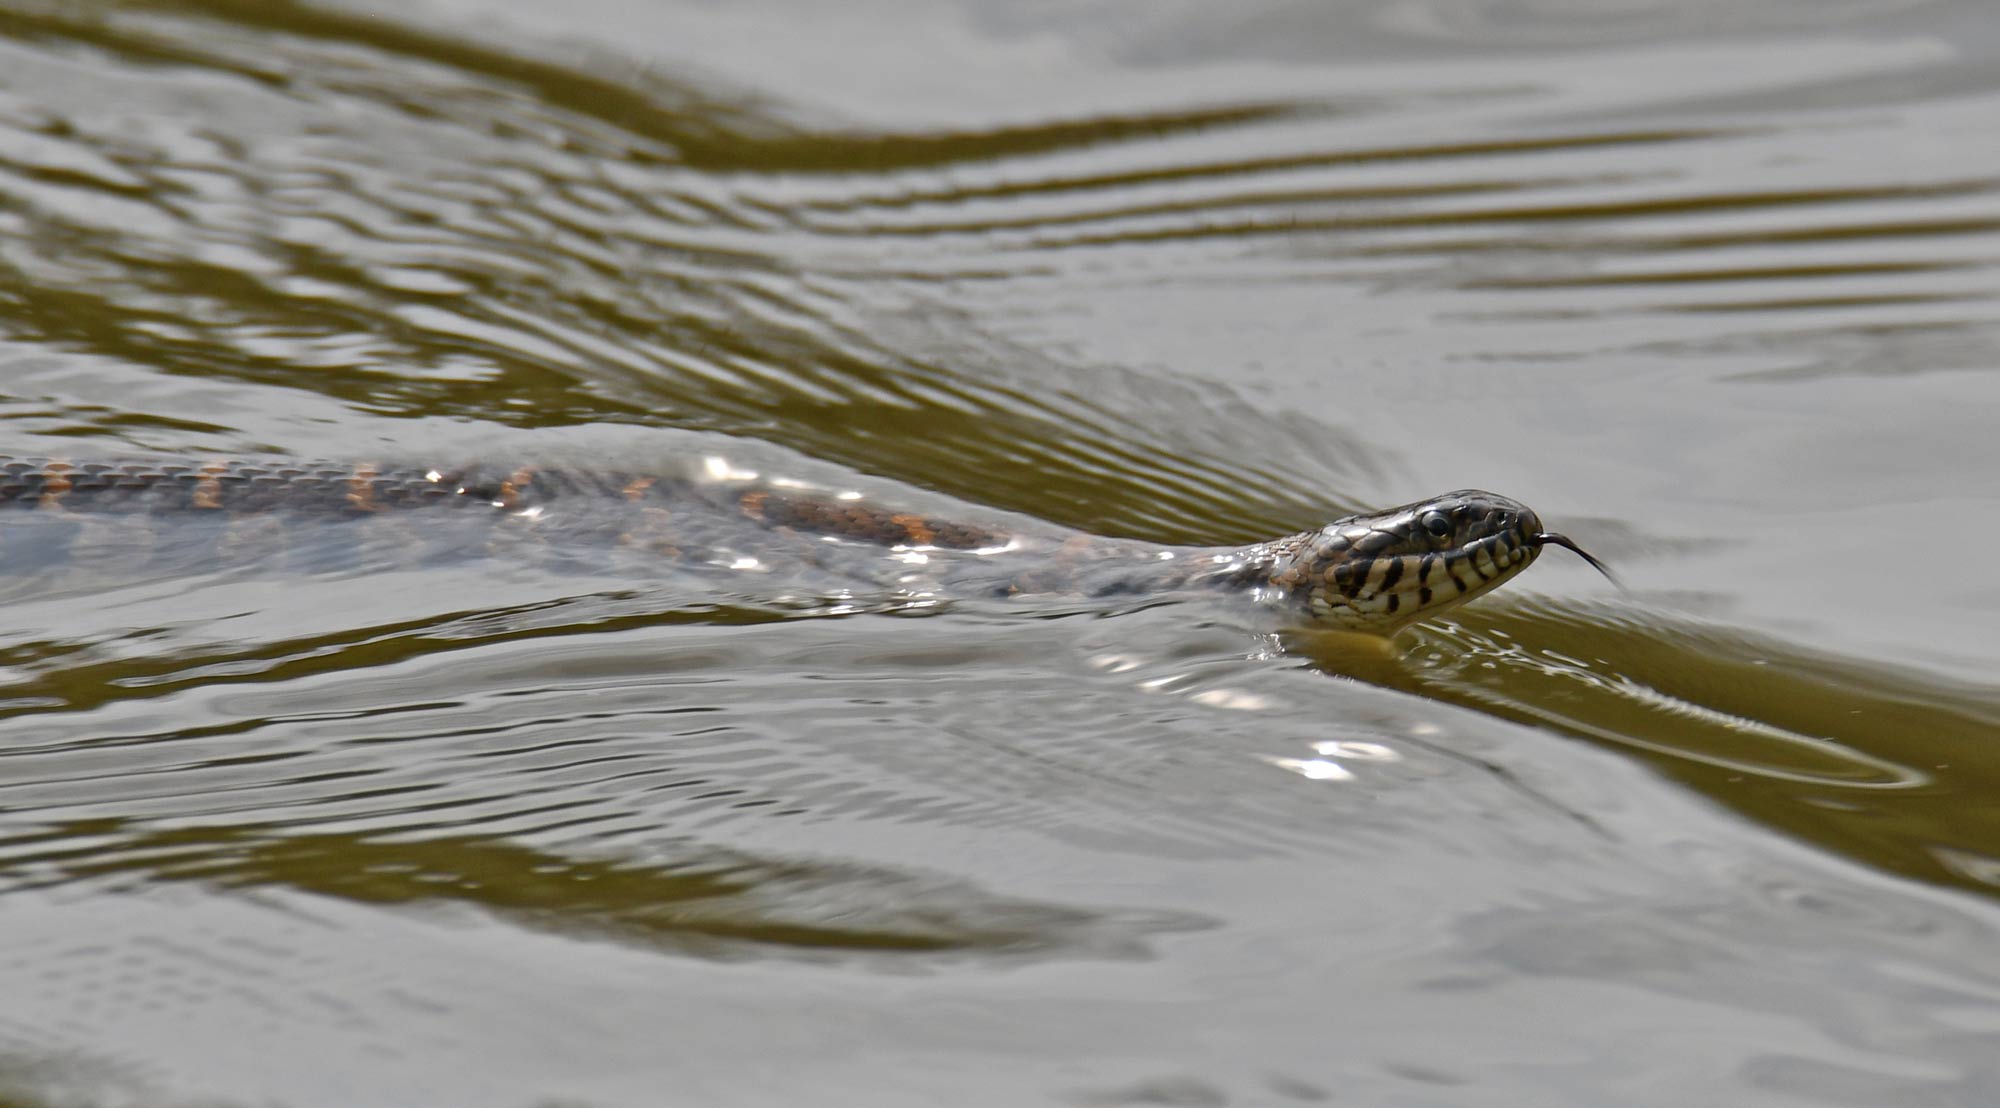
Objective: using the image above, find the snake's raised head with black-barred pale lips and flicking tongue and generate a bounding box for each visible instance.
[1272,488,1610,634]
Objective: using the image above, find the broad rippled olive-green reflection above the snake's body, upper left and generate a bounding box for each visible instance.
[0,0,1376,542]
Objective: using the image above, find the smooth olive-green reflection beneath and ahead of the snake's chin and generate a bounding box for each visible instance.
[1294,600,2000,894]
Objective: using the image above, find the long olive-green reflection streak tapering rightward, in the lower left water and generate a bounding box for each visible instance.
[8,814,1198,958]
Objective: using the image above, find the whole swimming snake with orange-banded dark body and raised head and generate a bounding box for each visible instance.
[0,458,1616,636]
